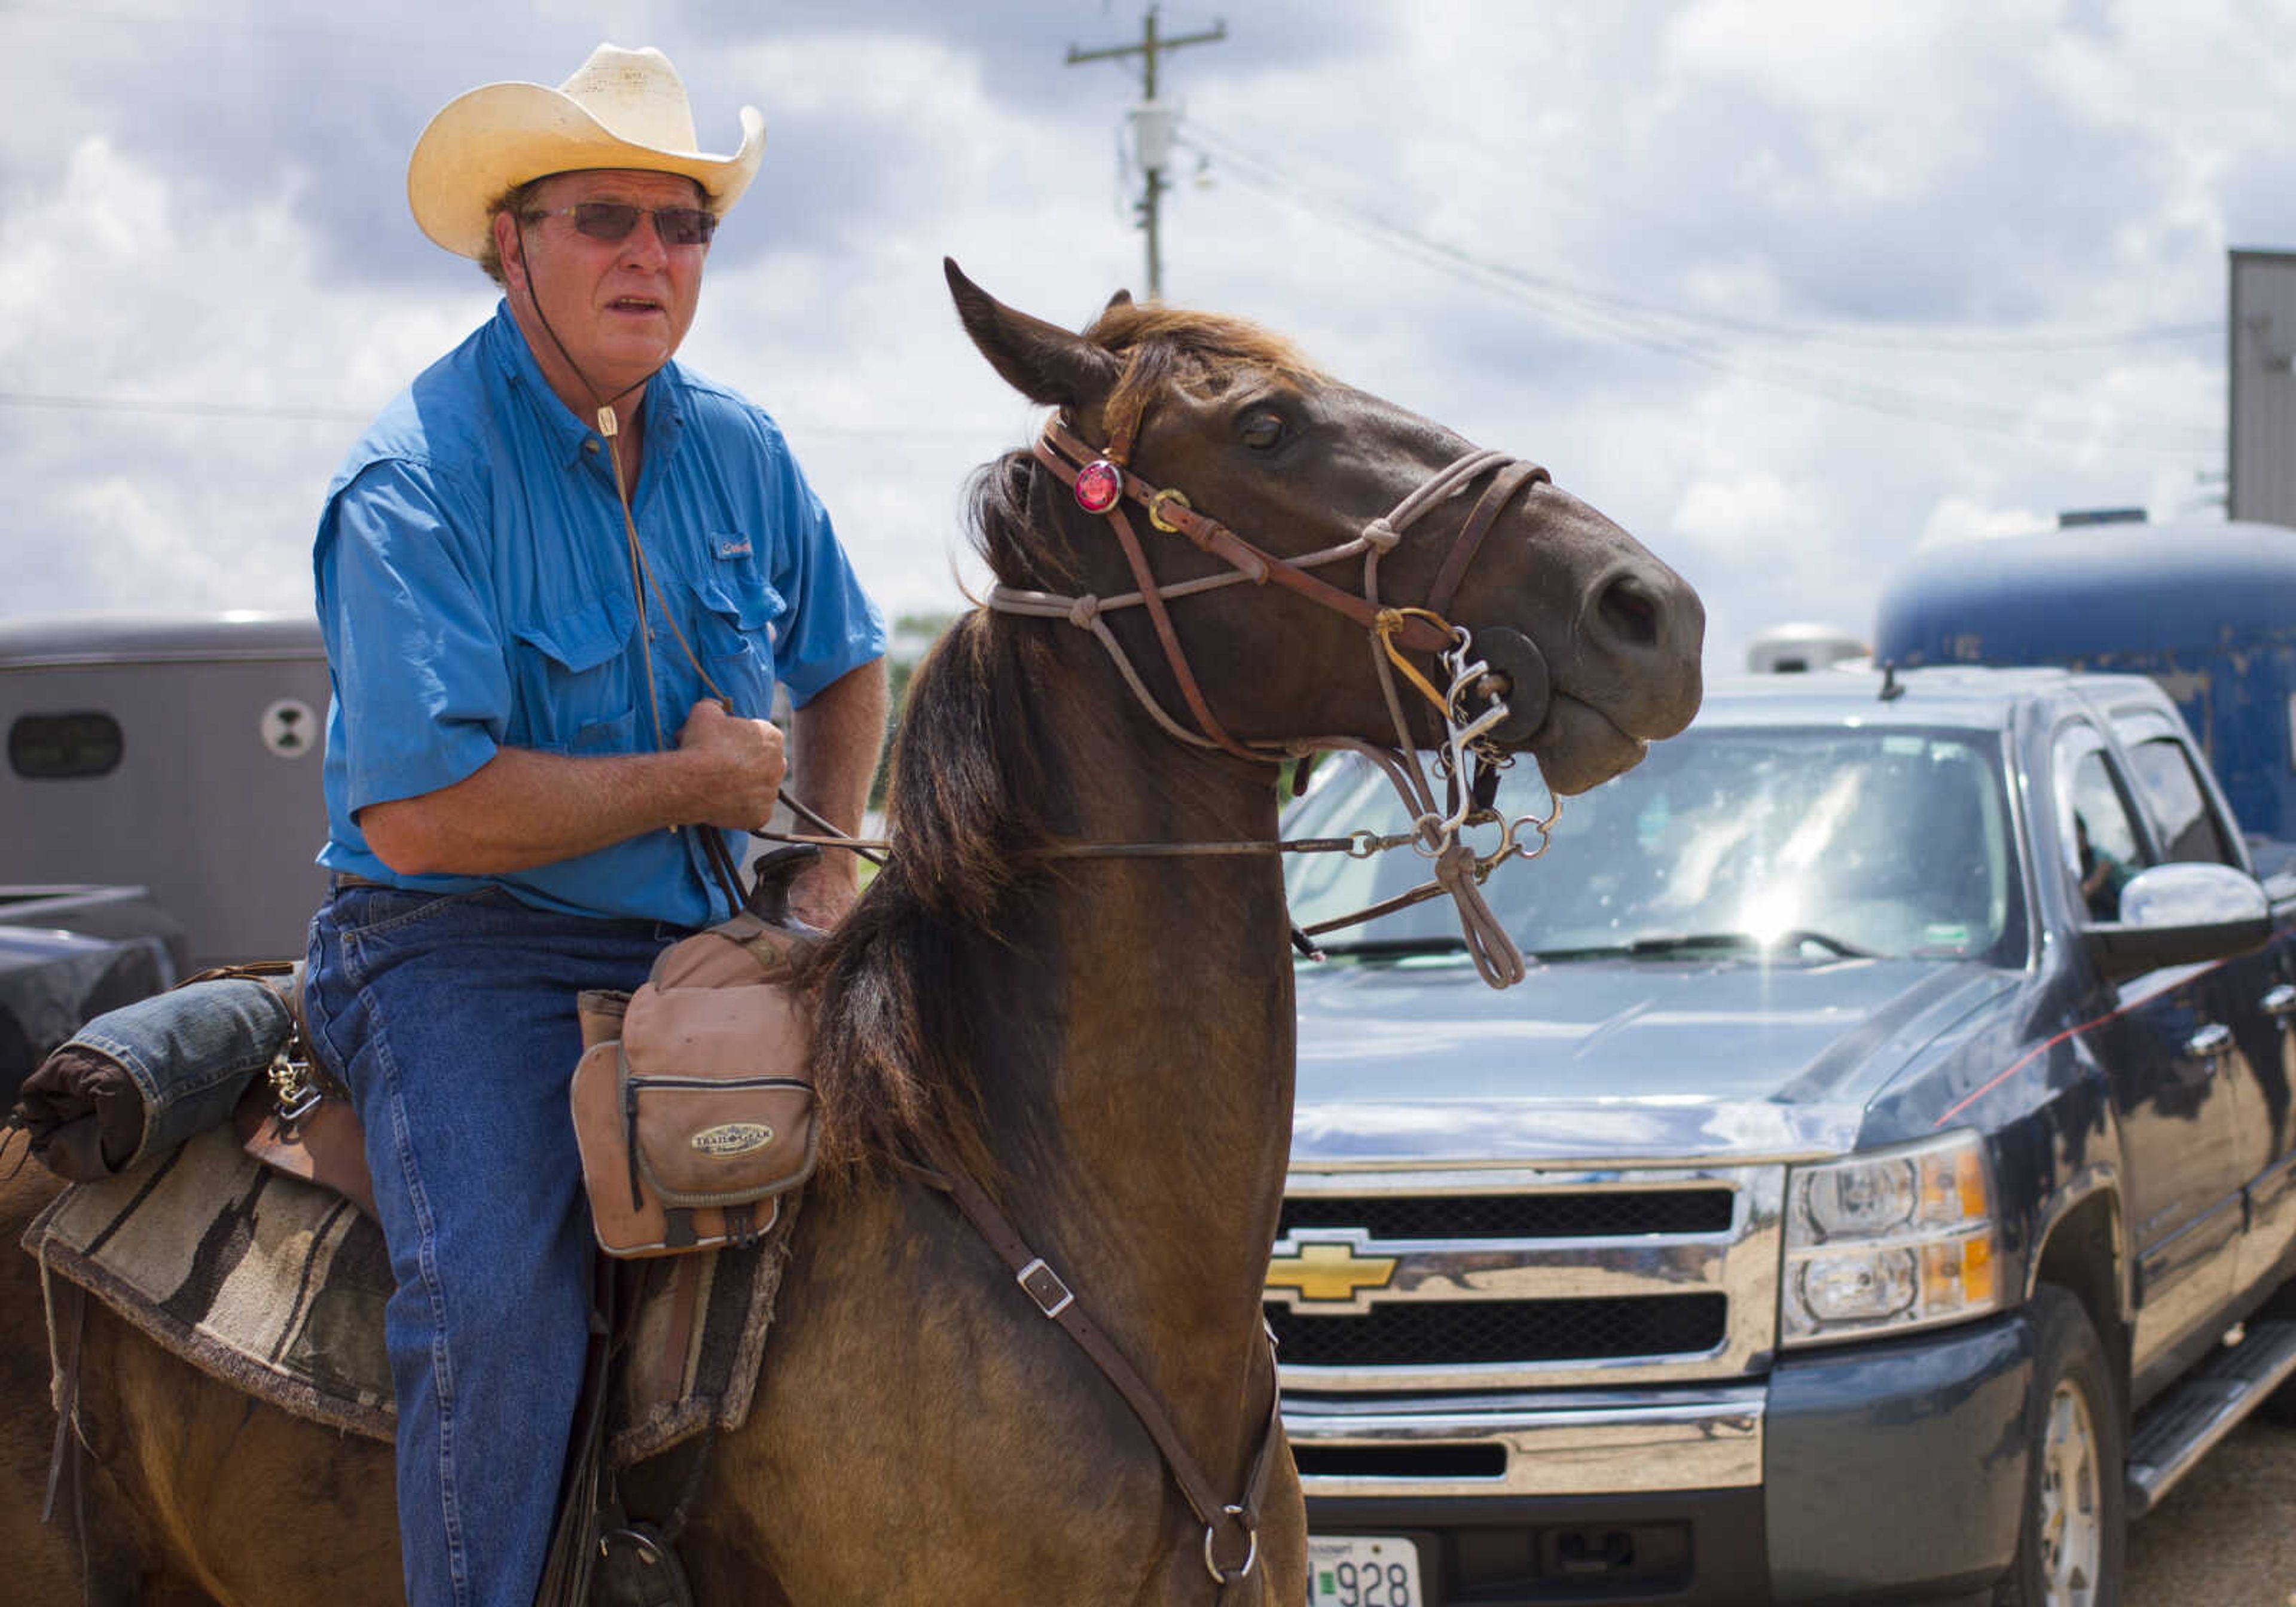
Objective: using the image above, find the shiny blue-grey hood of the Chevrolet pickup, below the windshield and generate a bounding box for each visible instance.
[1293,957,2016,1166]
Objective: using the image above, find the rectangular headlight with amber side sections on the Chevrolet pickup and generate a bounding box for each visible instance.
[1779,1132,2000,1345]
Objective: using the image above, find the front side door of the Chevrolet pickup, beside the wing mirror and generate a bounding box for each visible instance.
[2055,723,2241,1375]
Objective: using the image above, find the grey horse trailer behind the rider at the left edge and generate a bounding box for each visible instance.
[0,613,328,967]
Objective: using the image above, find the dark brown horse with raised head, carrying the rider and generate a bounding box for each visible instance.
[0,266,1701,1607]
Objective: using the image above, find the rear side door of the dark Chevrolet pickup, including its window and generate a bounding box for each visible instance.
[2115,714,2296,1288]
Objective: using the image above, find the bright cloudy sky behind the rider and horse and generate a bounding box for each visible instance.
[0,0,2296,670]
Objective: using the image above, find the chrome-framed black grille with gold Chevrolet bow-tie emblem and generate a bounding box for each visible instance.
[1268,1166,1784,1394]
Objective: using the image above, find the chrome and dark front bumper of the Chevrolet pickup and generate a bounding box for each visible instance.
[1284,1315,2032,1607]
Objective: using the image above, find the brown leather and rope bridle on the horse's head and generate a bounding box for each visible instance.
[987,416,1555,987]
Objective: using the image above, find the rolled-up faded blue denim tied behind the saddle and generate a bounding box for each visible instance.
[71,978,294,1171]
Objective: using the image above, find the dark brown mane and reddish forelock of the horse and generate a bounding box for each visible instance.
[801,301,1318,1189]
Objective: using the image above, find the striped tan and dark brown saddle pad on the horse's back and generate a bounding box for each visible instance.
[23,1127,796,1467]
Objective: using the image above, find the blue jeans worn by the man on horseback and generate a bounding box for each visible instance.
[306,886,680,1607]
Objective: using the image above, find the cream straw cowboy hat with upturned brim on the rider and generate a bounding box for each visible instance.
[407,44,765,257]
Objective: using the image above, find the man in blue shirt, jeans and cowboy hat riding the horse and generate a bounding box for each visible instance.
[308,46,884,1607]
